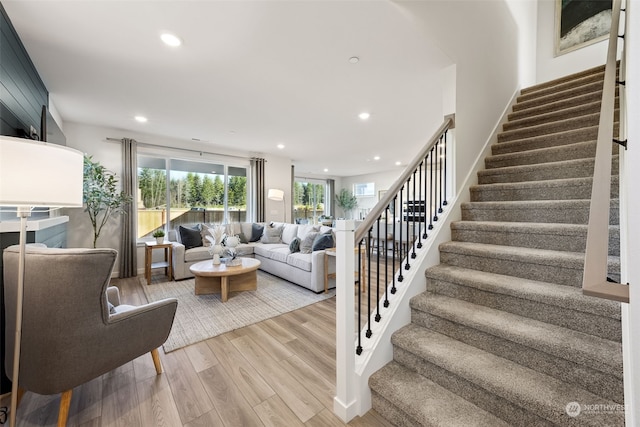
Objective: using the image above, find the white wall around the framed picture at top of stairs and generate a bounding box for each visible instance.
[537,0,607,83]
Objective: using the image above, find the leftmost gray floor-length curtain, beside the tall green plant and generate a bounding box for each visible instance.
[120,138,138,278]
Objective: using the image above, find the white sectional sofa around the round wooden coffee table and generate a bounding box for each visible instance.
[169,222,335,292]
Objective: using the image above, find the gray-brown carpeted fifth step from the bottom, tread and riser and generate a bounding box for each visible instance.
[439,242,619,287]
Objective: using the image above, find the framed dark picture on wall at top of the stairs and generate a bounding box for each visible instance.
[555,0,612,56]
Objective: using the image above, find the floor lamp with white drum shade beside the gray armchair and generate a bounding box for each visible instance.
[0,136,83,427]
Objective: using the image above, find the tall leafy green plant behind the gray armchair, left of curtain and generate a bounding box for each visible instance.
[82,155,131,248]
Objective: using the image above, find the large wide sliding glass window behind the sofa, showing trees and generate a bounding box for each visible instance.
[137,154,249,238]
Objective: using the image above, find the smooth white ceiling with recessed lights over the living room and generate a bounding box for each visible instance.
[2,0,450,176]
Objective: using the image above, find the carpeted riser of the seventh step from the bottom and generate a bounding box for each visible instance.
[462,200,619,225]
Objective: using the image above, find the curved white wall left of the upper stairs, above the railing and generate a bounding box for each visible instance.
[400,1,520,194]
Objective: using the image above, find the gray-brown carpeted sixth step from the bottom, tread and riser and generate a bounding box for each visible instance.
[451,221,620,256]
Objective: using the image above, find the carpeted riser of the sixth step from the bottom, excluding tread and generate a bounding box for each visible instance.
[451,227,620,256]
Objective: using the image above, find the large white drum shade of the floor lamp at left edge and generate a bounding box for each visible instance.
[0,136,84,207]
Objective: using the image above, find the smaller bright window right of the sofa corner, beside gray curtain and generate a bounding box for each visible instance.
[293,178,328,224]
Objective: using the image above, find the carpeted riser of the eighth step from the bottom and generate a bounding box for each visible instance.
[470,177,619,202]
